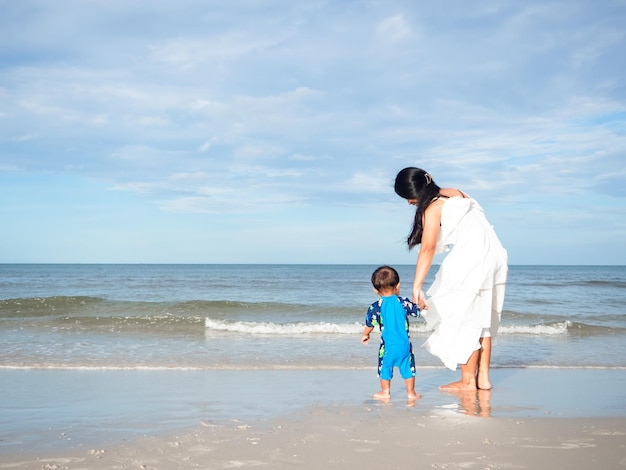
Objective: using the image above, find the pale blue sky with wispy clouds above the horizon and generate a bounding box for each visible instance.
[0,0,626,265]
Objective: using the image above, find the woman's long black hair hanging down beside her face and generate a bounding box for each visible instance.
[394,167,441,250]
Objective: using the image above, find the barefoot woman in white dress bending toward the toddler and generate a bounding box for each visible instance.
[395,167,508,391]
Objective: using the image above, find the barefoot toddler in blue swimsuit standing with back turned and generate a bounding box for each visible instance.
[361,266,421,400]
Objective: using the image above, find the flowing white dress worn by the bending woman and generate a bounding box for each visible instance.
[422,197,508,370]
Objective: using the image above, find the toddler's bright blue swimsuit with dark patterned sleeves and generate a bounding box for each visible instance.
[365,295,420,380]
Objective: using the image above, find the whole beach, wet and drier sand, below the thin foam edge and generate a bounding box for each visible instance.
[0,368,626,470]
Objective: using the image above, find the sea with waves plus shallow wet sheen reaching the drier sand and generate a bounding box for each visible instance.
[0,264,626,457]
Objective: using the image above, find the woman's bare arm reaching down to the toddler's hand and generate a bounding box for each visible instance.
[413,199,444,309]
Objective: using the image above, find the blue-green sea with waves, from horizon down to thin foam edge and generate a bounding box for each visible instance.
[0,264,626,370]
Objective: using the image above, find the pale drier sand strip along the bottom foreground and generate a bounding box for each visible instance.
[0,407,626,470]
